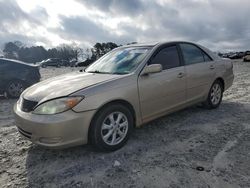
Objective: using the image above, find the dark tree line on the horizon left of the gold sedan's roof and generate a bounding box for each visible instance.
[3,41,121,63]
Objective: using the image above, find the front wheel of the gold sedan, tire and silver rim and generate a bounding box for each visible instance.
[89,104,134,151]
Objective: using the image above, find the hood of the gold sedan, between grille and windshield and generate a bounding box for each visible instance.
[22,71,124,103]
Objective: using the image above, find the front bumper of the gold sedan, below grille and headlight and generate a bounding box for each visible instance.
[14,104,95,148]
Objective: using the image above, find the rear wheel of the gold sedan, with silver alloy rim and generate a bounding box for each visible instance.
[204,80,223,109]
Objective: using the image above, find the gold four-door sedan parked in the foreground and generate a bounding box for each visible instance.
[14,42,234,151]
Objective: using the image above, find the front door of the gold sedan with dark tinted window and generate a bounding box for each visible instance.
[138,45,186,122]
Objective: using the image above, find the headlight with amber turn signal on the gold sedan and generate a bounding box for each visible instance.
[33,97,83,114]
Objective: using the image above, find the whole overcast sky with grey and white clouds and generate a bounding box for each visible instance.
[0,0,250,51]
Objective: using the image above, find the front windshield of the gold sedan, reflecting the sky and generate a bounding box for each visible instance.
[85,47,151,74]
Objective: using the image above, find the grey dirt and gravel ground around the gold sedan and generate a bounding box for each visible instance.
[0,61,250,188]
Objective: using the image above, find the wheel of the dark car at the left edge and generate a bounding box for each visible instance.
[6,80,26,99]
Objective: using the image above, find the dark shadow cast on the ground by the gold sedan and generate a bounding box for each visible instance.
[26,101,250,187]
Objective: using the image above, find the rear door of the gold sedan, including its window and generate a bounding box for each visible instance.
[179,43,216,102]
